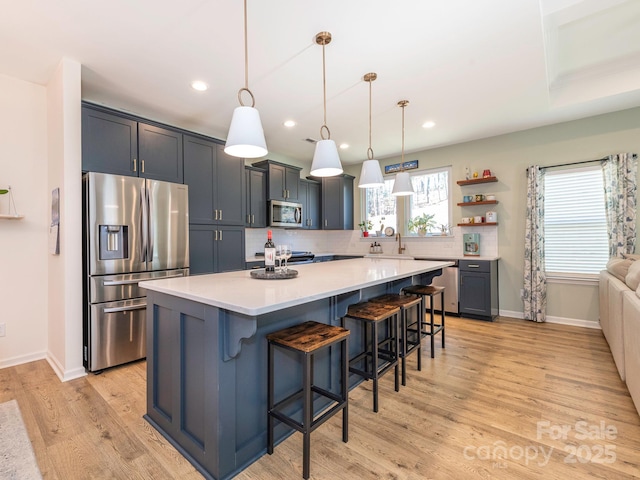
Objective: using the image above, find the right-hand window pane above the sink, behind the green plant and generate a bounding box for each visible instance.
[406,167,451,235]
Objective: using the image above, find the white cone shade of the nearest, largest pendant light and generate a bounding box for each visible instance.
[224,106,269,158]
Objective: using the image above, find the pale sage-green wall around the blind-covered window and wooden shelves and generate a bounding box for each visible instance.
[347,108,640,324]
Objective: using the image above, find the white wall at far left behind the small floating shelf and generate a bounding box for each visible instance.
[0,75,49,367]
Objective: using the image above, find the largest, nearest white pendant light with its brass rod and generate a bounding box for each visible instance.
[224,0,268,158]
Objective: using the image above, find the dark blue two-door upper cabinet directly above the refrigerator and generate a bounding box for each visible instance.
[82,105,183,183]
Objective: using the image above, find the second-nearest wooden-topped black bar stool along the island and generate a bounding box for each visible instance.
[342,302,400,412]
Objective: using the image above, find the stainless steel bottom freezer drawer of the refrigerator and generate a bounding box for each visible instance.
[85,297,147,372]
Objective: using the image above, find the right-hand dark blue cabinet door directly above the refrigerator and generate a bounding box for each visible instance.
[138,123,183,183]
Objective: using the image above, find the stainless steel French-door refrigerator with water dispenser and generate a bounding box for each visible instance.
[83,172,189,372]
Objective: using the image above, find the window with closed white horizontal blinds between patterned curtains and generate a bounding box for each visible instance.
[544,166,609,276]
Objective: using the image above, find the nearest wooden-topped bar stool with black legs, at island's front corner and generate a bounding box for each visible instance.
[267,322,350,479]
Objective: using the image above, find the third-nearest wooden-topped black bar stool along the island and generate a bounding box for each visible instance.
[369,293,424,385]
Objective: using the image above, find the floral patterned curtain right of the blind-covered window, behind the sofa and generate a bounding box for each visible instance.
[602,153,638,257]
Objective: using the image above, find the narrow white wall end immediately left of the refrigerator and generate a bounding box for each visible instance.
[46,59,85,380]
